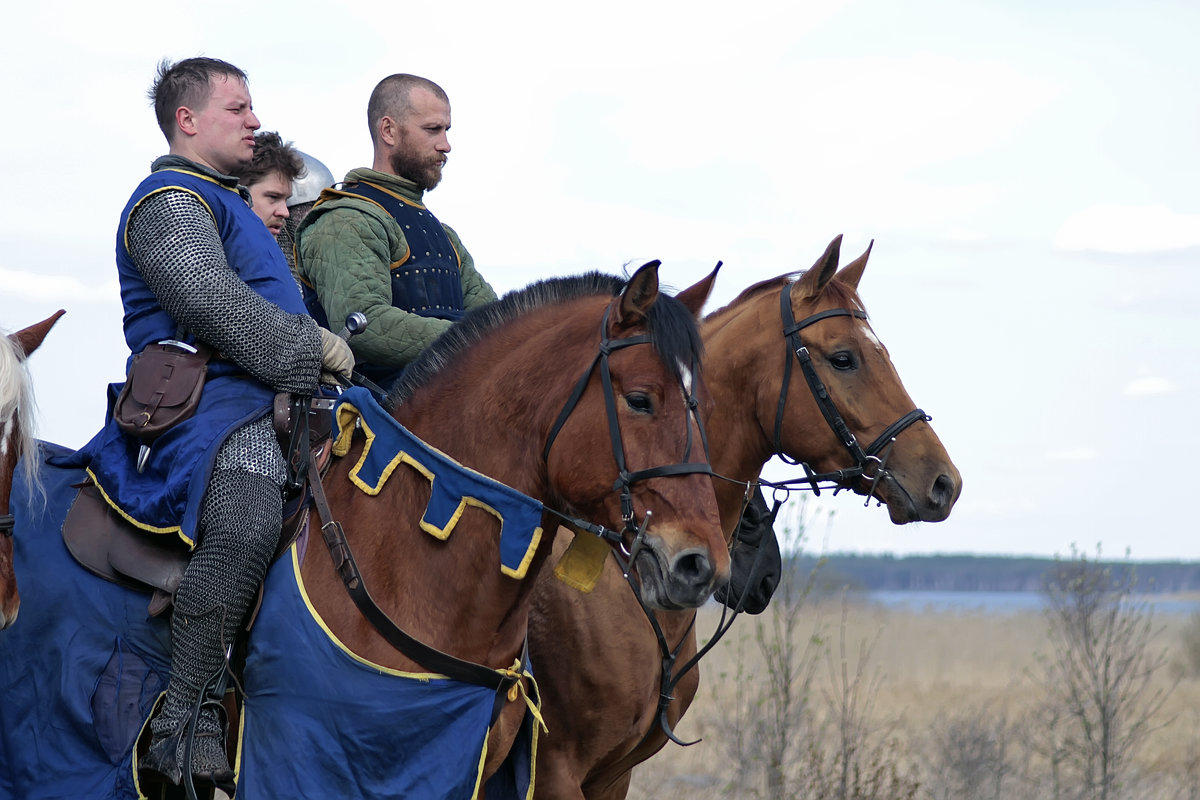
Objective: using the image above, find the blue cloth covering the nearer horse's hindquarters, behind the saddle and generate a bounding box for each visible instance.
[0,445,170,800]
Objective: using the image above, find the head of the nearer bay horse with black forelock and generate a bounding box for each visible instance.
[545,261,728,608]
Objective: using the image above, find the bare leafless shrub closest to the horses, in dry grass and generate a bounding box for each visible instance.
[708,501,919,800]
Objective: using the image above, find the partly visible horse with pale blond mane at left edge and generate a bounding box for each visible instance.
[0,309,64,630]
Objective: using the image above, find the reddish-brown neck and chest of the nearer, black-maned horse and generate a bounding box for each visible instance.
[338,303,598,666]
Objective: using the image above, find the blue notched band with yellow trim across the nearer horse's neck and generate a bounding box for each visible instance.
[334,386,542,579]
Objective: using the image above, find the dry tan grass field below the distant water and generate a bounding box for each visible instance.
[629,599,1200,800]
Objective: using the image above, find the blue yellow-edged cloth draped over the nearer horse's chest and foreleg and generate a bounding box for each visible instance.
[238,546,535,800]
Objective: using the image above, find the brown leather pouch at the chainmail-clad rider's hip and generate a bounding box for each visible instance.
[113,342,212,441]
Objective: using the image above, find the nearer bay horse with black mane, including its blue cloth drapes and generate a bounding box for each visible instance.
[0,263,730,800]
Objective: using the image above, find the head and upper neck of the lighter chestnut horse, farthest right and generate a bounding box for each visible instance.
[706,236,962,524]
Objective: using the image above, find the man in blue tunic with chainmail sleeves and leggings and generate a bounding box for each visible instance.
[79,58,353,793]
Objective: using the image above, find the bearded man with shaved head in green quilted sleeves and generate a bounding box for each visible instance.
[296,74,496,386]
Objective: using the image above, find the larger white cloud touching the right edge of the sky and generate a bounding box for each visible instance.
[1054,204,1200,254]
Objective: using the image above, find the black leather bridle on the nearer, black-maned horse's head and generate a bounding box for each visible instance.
[541,306,713,551]
